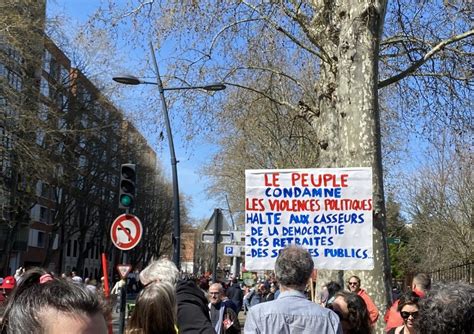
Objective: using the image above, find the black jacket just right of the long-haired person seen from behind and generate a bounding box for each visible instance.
[176,280,215,334]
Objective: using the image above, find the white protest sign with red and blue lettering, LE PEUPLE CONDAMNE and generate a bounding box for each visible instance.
[245,167,373,270]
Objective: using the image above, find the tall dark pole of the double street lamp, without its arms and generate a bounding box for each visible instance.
[150,42,181,270]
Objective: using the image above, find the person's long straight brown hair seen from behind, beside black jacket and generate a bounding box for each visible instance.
[127,282,178,334]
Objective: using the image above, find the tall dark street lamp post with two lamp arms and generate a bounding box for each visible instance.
[113,42,226,269]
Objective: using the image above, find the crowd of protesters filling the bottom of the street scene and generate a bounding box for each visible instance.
[0,246,474,334]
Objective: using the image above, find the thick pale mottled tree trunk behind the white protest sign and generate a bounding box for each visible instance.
[313,0,391,331]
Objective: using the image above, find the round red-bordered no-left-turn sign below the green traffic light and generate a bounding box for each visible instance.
[110,214,143,250]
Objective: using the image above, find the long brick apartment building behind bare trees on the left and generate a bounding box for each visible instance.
[0,1,156,278]
